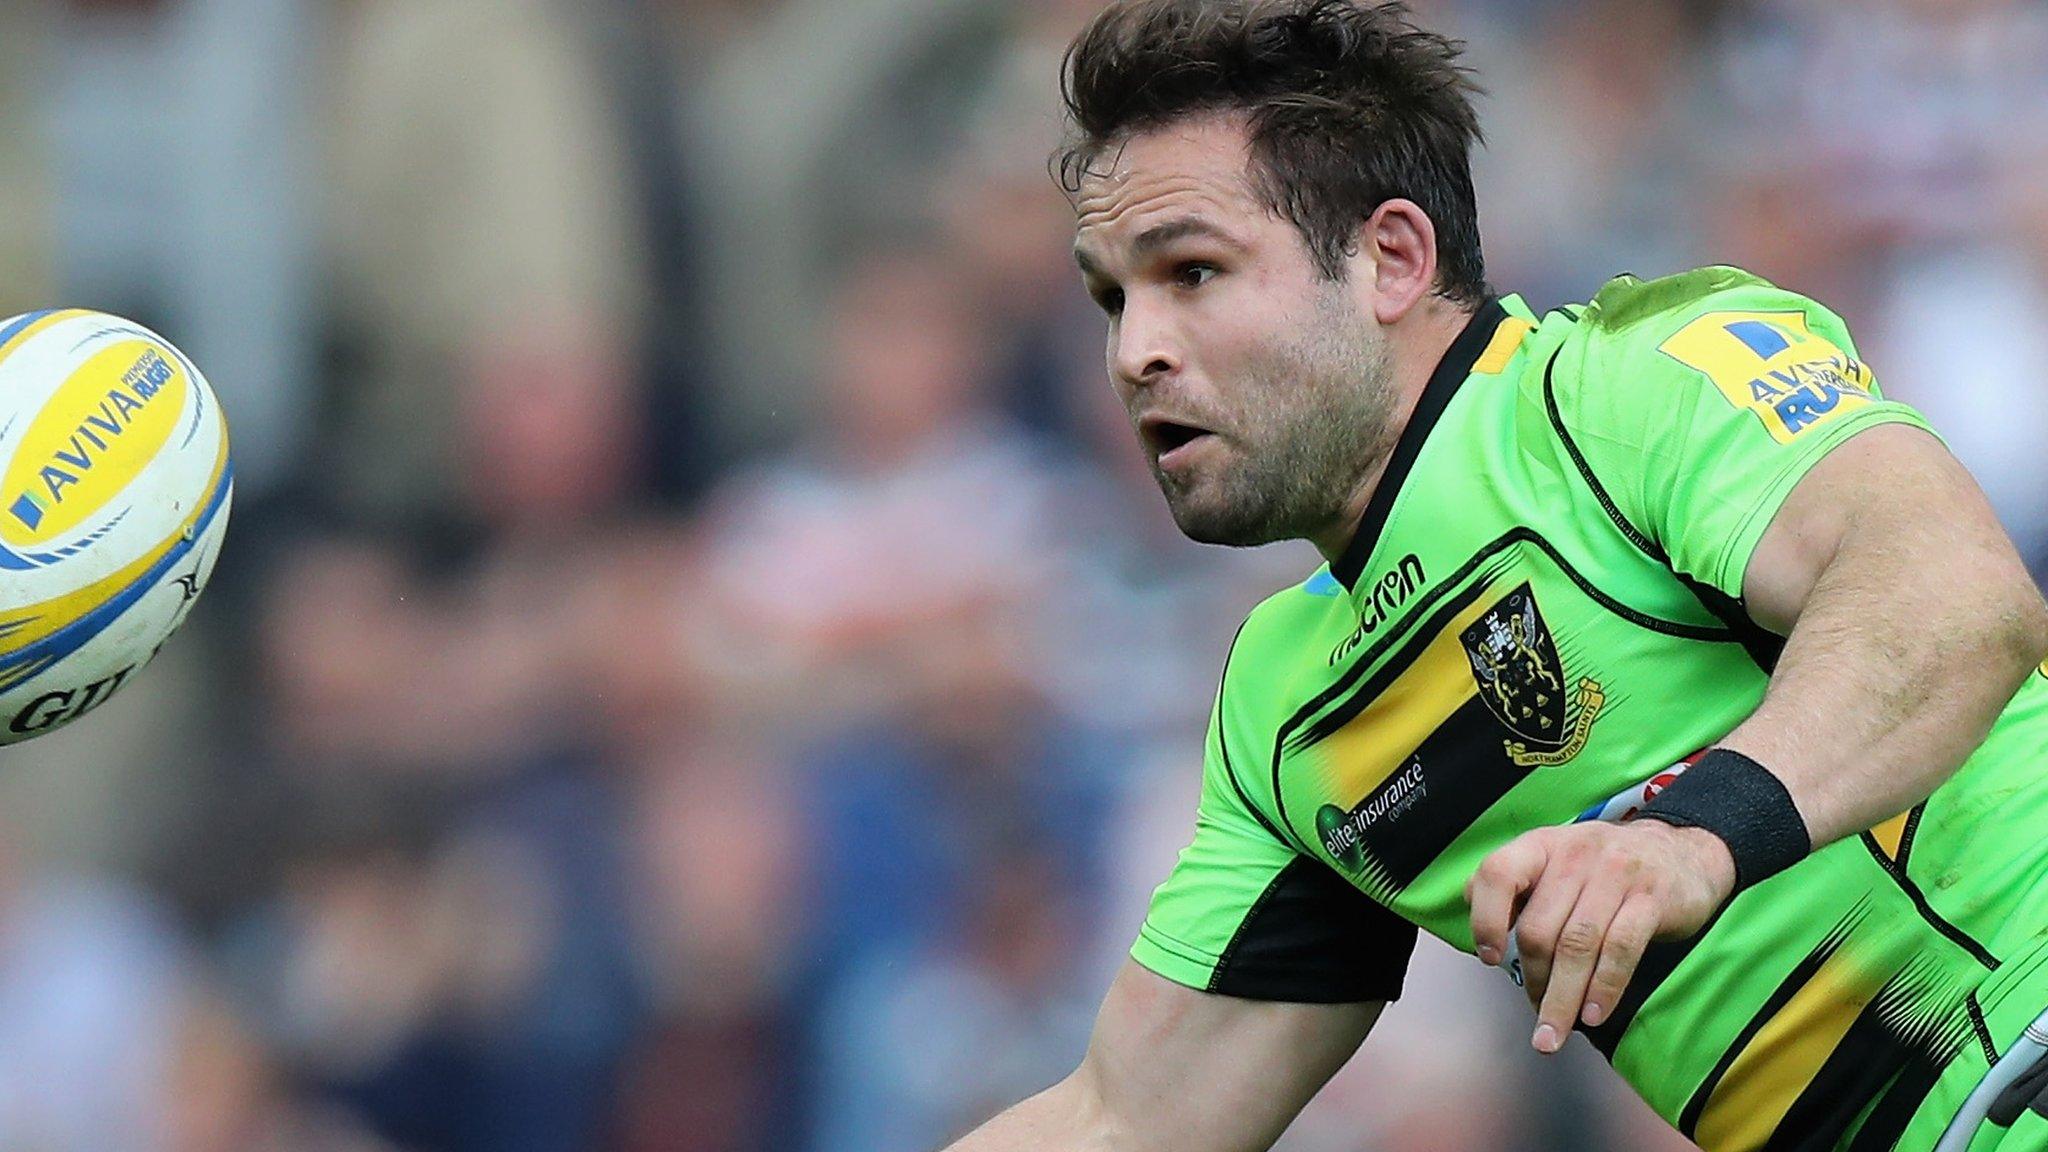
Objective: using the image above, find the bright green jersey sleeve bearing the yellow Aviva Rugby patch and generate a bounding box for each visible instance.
[1544,269,1931,601]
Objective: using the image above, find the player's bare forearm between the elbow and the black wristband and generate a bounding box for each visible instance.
[1724,471,2048,847]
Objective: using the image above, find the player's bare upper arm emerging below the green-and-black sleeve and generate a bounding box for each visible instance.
[1063,963,1384,1152]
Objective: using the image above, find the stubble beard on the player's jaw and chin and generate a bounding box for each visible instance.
[1153,287,1393,547]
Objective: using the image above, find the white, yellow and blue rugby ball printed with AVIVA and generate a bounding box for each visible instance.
[0,310,233,744]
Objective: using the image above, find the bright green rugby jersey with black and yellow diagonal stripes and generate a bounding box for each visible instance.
[1133,269,2048,1152]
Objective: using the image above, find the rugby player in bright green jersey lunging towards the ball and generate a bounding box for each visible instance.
[956,0,2048,1152]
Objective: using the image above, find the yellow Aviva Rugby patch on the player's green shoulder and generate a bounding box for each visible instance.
[1659,310,1874,445]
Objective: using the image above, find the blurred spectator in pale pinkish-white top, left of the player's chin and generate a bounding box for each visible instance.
[700,250,1055,726]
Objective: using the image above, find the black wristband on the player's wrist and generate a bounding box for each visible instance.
[1636,748,1812,892]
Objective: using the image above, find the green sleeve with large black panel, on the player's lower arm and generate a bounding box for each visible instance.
[1130,668,1415,1004]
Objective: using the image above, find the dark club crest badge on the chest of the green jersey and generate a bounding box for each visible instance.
[1458,584,1606,769]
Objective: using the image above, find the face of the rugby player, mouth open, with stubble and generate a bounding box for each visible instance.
[1075,117,1393,545]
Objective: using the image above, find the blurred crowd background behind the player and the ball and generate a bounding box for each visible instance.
[0,0,2048,1152]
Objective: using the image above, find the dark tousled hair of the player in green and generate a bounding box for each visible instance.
[1055,0,1491,305]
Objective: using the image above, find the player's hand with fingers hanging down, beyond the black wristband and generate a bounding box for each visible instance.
[1464,820,1735,1054]
